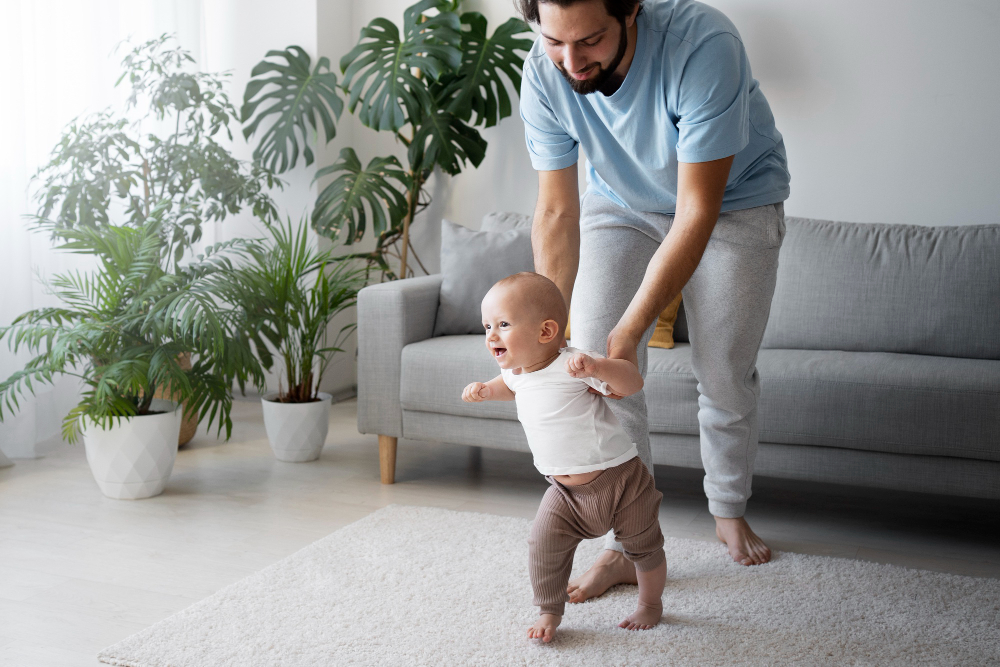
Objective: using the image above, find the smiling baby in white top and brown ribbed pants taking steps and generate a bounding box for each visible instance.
[462,272,667,642]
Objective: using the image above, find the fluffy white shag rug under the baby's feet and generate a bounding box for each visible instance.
[98,506,1000,667]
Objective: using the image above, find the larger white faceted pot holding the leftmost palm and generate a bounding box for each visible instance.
[83,399,184,500]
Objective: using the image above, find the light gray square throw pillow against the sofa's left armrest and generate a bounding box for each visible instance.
[434,220,535,336]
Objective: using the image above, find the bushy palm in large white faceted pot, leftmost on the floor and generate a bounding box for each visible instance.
[0,217,264,499]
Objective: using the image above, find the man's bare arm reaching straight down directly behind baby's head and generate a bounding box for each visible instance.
[531,164,580,308]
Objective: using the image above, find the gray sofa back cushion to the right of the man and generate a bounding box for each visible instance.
[762,217,1000,359]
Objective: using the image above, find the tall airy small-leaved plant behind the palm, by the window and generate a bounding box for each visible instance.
[31,35,281,444]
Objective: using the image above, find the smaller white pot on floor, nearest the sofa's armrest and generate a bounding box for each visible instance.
[260,392,330,463]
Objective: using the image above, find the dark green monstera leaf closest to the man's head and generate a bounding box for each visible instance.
[446,12,534,127]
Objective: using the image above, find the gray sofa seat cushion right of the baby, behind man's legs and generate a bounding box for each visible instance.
[646,343,1000,461]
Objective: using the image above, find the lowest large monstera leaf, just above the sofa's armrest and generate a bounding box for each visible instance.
[312,148,410,245]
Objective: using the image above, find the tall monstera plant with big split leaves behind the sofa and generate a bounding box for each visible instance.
[241,0,532,279]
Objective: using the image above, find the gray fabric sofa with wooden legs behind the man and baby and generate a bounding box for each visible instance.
[358,218,1000,498]
